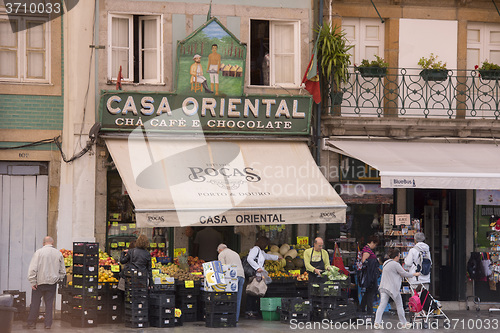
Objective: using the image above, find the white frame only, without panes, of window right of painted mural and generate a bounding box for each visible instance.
[249,18,302,88]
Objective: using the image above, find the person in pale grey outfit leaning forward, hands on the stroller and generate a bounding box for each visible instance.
[373,248,420,329]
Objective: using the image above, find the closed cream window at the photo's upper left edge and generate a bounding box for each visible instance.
[0,16,50,82]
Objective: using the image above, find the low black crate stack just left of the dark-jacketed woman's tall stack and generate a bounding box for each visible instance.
[97,282,124,324]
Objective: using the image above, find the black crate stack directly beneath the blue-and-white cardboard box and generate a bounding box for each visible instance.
[203,292,238,328]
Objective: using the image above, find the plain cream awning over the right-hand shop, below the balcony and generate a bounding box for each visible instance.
[326,139,500,189]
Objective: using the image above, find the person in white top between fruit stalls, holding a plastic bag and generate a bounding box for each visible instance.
[246,236,279,319]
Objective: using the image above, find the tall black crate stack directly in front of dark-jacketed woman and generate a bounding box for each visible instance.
[124,269,149,328]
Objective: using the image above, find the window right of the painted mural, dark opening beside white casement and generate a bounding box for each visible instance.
[250,20,300,87]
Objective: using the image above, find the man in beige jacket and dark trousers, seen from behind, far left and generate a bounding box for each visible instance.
[26,236,66,329]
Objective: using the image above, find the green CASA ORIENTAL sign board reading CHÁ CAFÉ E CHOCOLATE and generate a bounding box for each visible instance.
[100,92,312,135]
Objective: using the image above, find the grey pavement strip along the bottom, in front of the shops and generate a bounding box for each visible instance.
[8,308,500,333]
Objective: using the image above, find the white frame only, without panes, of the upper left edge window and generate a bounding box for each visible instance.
[0,15,51,83]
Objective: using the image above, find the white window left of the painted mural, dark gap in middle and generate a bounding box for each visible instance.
[108,15,163,83]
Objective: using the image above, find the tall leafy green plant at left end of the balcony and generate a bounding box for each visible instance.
[316,24,353,105]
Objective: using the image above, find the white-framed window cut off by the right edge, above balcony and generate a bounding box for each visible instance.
[467,23,500,69]
